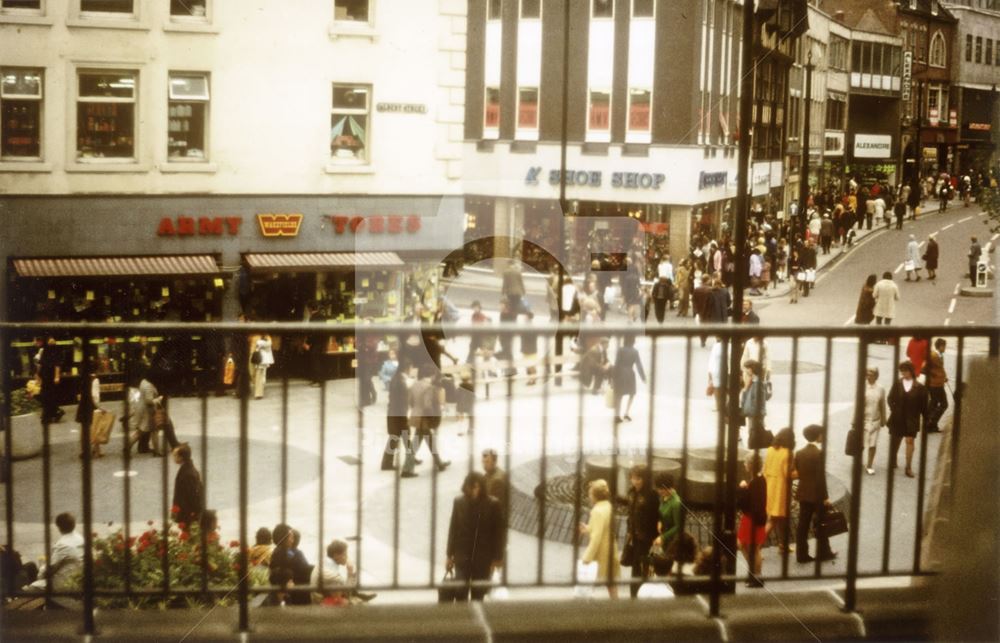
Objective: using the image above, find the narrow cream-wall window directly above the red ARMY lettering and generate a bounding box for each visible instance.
[167,74,208,161]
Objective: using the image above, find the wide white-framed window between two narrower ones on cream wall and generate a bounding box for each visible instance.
[76,70,138,161]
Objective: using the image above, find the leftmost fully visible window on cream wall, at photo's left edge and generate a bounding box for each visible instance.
[0,67,42,159]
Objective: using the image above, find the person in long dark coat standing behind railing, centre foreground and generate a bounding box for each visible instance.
[446,472,506,601]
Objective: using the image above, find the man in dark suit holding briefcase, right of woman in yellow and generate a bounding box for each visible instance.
[795,424,837,563]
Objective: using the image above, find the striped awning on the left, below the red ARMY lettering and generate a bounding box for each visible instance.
[14,255,219,277]
